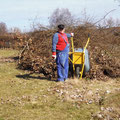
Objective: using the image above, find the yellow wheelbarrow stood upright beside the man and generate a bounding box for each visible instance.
[69,35,90,79]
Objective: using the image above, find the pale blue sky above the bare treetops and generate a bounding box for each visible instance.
[0,0,120,31]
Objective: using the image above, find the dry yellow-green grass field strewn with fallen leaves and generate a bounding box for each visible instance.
[0,50,120,120]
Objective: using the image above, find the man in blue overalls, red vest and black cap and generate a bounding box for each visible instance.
[52,24,74,82]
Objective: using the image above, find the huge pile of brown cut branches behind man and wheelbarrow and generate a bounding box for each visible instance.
[19,26,120,80]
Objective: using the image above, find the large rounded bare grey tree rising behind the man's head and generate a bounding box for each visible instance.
[49,8,74,28]
